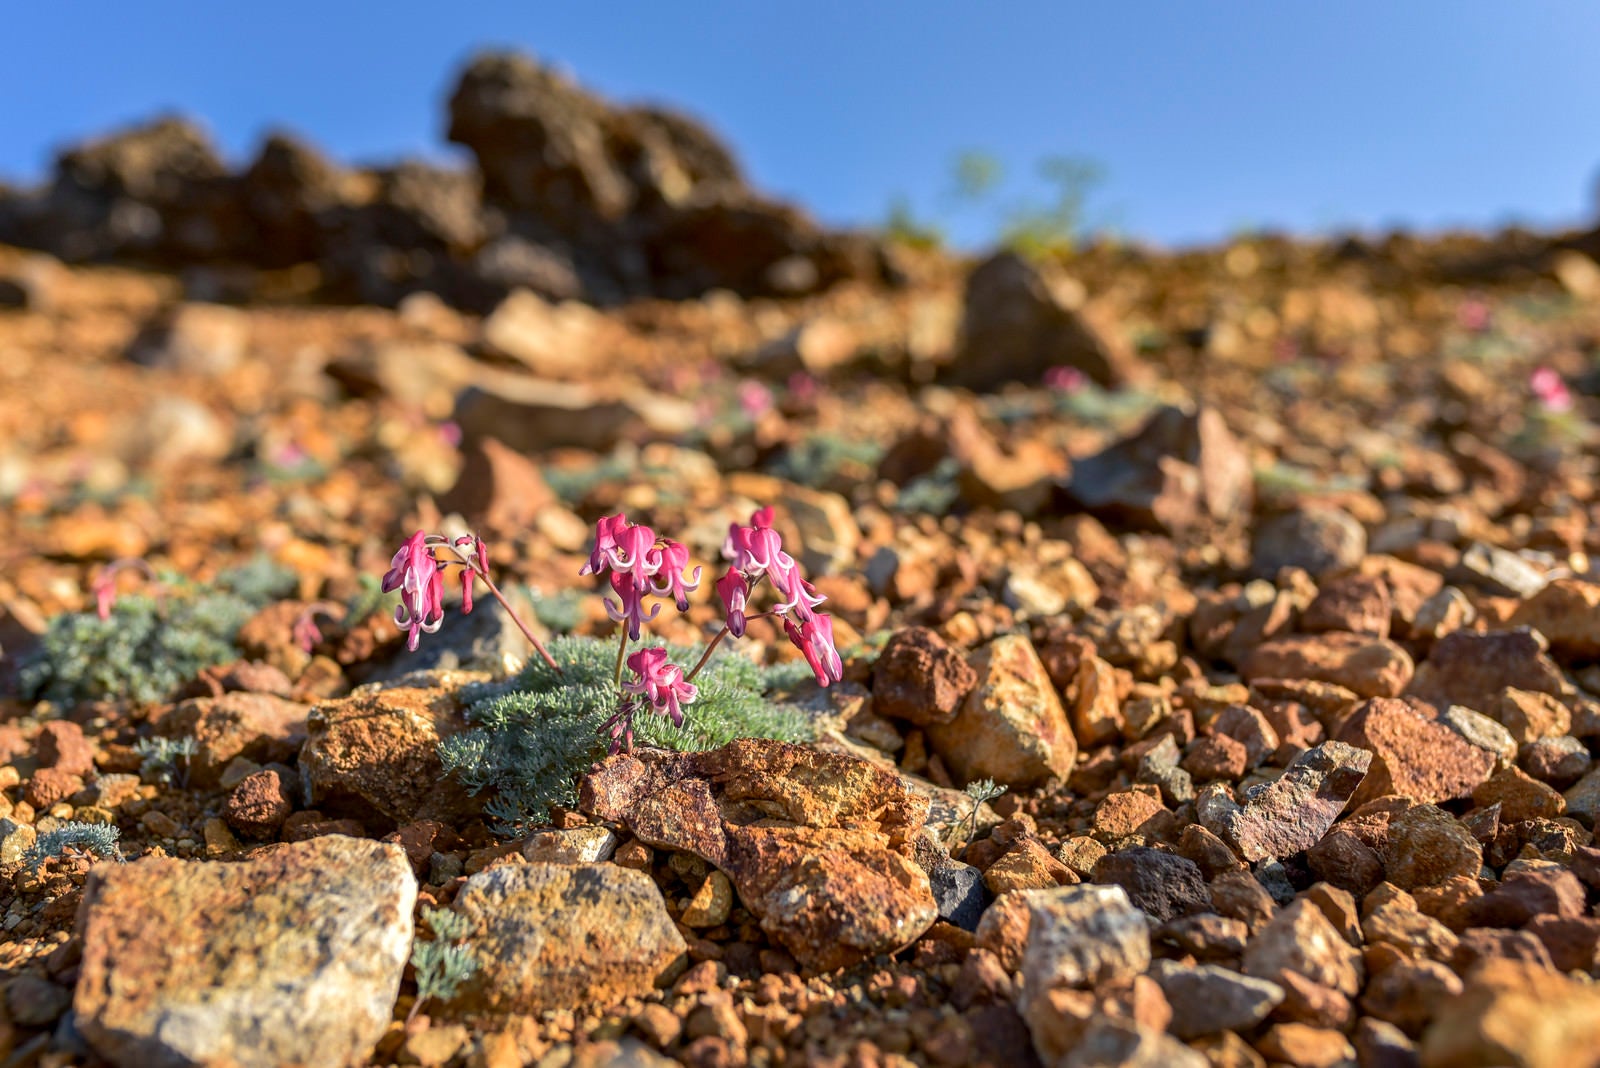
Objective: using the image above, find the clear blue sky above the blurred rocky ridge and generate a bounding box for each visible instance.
[0,0,1600,243]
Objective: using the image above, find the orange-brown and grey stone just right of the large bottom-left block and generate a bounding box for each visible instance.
[453,862,686,1014]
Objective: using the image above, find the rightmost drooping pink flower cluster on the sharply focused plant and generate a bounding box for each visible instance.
[717,507,845,686]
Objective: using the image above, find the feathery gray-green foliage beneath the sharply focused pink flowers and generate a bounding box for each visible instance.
[440,636,811,831]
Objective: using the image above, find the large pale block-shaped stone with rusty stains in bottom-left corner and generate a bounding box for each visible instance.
[74,836,416,1068]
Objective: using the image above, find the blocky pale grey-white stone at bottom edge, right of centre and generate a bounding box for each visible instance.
[1021,884,1150,1015]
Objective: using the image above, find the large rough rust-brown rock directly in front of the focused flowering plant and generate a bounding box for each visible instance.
[579,739,938,970]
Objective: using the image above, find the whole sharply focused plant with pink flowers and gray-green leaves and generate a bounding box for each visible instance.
[382,508,843,828]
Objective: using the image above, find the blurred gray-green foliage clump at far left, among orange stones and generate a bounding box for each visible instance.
[19,560,294,702]
